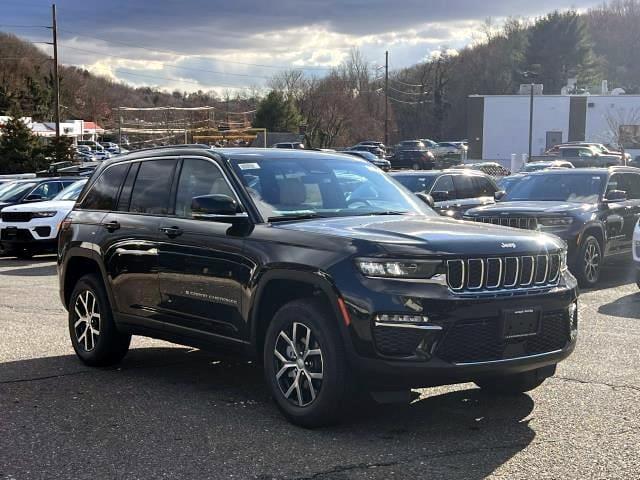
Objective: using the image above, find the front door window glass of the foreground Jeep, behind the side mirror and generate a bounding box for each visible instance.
[176,159,235,217]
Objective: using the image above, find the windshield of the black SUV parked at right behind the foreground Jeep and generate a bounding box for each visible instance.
[502,172,606,203]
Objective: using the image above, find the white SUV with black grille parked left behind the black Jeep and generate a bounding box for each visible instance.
[0,179,87,259]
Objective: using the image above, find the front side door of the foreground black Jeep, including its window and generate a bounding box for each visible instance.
[159,157,251,338]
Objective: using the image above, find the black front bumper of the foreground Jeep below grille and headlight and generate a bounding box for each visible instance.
[344,272,578,389]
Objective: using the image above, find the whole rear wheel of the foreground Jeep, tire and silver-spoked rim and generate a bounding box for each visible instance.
[69,274,131,367]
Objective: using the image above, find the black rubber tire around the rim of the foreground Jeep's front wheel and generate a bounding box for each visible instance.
[263,299,349,427]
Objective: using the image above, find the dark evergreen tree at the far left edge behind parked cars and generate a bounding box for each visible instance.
[0,108,39,173]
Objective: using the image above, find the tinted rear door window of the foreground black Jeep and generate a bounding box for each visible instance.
[129,160,176,215]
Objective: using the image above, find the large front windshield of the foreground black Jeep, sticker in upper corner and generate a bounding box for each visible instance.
[232,156,435,221]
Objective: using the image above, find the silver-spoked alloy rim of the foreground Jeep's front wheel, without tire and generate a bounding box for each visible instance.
[273,322,323,407]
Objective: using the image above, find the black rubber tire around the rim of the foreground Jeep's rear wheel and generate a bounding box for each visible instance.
[69,275,131,366]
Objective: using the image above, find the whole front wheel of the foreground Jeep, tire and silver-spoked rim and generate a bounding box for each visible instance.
[263,299,352,428]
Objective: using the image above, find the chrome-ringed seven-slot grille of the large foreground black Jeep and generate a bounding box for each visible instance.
[447,253,561,293]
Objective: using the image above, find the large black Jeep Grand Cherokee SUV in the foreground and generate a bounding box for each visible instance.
[58,146,578,426]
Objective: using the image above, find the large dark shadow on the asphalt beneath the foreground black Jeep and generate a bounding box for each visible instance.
[0,348,535,480]
